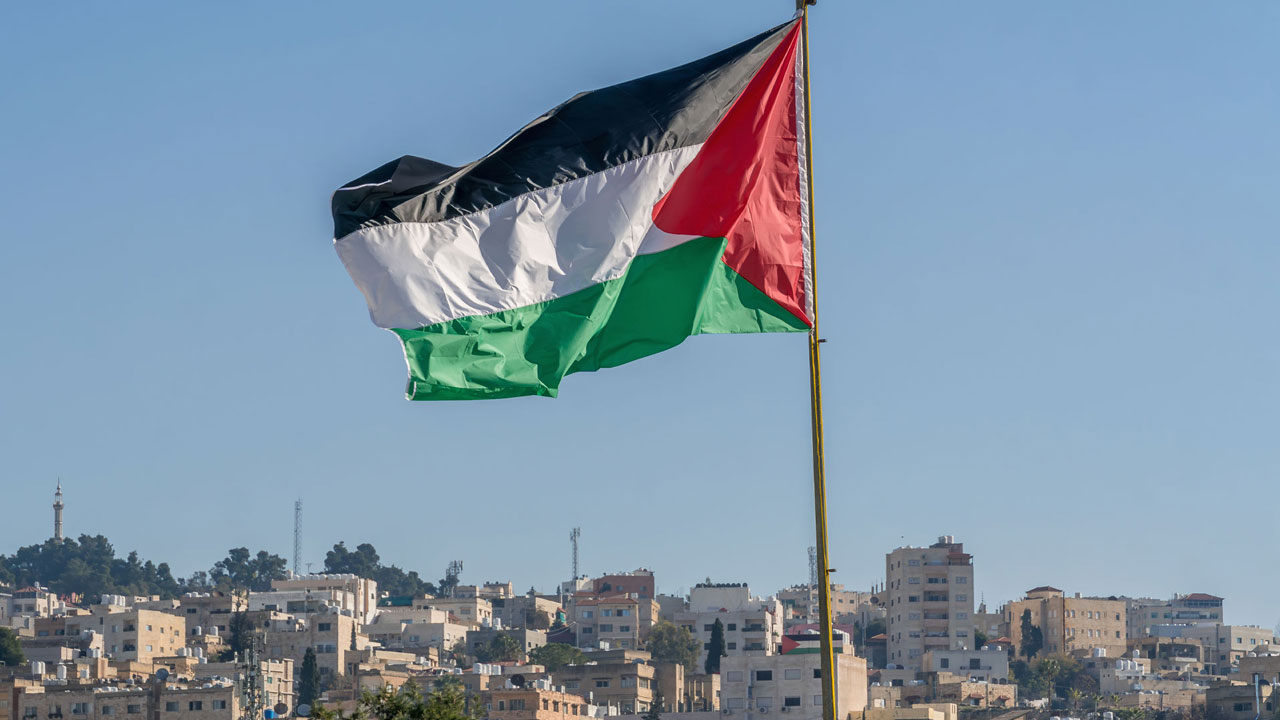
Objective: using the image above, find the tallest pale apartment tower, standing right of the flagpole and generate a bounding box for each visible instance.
[884,536,973,670]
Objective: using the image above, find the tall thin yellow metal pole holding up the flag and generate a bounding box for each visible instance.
[796,0,840,720]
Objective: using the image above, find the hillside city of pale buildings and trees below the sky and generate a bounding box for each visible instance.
[0,488,1280,720]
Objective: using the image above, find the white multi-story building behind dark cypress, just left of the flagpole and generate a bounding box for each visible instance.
[672,583,783,666]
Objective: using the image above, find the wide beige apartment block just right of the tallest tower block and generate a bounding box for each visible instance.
[1005,585,1128,657]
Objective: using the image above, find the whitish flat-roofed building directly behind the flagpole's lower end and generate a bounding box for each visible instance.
[721,630,867,720]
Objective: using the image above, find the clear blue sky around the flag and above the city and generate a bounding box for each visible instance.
[0,0,1280,625]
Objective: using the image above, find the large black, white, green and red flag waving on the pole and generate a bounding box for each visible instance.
[333,20,813,400]
